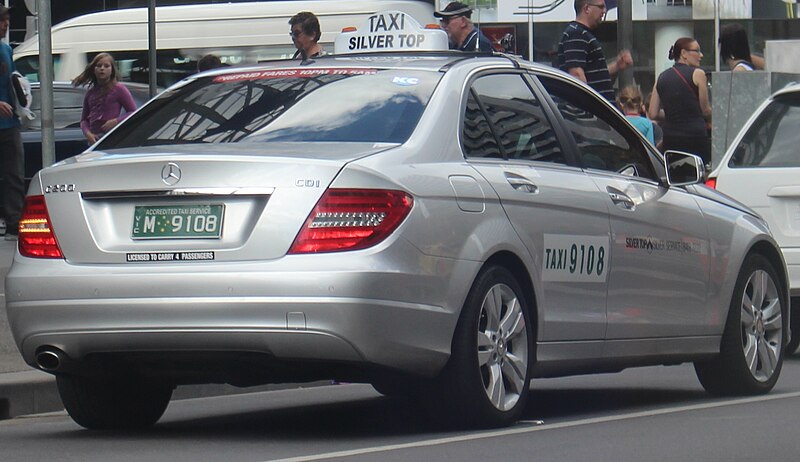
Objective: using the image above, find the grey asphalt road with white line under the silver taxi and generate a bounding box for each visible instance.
[0,356,800,462]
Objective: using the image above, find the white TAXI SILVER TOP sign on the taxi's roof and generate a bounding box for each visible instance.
[333,11,449,55]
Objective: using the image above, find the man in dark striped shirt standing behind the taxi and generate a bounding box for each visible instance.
[558,0,633,101]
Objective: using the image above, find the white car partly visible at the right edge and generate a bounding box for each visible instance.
[706,85,800,352]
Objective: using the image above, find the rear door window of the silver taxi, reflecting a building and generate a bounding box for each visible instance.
[464,74,566,164]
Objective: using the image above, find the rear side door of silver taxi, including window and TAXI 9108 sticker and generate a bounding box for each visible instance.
[462,73,609,341]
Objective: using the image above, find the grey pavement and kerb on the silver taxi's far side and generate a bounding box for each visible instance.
[0,236,329,420]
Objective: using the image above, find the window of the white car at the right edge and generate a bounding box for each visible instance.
[728,95,800,168]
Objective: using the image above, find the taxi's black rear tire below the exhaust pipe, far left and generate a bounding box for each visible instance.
[56,375,173,430]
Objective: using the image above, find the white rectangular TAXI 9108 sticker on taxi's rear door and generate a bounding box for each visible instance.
[542,234,610,282]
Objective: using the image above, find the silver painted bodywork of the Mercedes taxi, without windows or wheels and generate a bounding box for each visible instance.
[7,58,788,375]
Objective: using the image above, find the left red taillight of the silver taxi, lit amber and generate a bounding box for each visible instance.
[19,196,64,258]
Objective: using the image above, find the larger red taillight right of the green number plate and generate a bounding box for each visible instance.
[289,189,414,254]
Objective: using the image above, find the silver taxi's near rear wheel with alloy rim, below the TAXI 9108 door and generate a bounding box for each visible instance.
[440,266,534,427]
